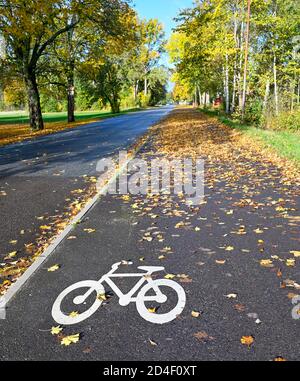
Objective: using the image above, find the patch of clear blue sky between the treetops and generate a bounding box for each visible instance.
[133,0,193,37]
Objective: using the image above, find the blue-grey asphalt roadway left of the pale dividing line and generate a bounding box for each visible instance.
[0,107,172,262]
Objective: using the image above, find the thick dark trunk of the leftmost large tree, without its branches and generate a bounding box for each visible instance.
[25,69,44,131]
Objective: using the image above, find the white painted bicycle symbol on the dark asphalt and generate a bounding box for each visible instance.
[52,262,186,325]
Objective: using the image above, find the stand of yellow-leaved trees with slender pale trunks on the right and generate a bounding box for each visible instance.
[168,0,300,123]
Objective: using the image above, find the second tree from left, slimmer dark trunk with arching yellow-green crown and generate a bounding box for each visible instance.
[42,0,135,122]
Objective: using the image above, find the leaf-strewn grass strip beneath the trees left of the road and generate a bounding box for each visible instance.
[0,108,141,146]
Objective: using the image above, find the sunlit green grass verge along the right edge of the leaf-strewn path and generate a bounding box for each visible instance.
[201,109,300,165]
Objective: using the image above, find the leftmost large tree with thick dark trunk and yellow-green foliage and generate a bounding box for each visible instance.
[0,0,83,130]
